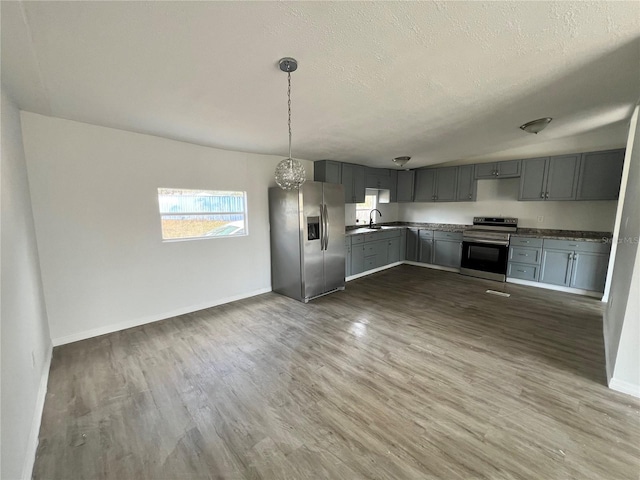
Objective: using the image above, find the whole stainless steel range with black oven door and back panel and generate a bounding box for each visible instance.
[460,217,518,282]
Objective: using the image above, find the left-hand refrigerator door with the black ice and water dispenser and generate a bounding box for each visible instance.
[300,182,325,299]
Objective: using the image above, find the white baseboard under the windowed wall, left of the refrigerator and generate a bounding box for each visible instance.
[52,287,271,347]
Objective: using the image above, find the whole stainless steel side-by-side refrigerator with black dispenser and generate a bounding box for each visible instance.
[269,182,345,303]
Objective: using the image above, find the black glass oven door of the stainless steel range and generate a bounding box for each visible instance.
[460,240,509,281]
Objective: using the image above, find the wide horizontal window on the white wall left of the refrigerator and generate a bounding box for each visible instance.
[158,188,247,240]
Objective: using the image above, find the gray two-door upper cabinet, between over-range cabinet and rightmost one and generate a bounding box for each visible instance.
[518,155,580,201]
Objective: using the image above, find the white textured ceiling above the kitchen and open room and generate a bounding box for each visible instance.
[2,1,640,167]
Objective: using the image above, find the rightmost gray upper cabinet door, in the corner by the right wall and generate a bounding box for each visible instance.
[576,150,624,200]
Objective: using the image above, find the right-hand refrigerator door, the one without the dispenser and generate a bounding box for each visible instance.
[323,183,345,292]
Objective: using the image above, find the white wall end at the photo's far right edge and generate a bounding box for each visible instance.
[603,107,640,397]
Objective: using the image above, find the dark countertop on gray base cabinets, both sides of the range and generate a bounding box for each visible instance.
[346,222,612,243]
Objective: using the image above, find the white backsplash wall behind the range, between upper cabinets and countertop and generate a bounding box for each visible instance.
[398,178,617,232]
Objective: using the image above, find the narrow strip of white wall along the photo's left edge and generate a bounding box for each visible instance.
[0,92,51,479]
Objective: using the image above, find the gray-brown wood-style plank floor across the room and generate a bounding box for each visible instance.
[34,265,640,480]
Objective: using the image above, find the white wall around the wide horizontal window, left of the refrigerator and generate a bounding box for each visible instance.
[22,112,313,345]
